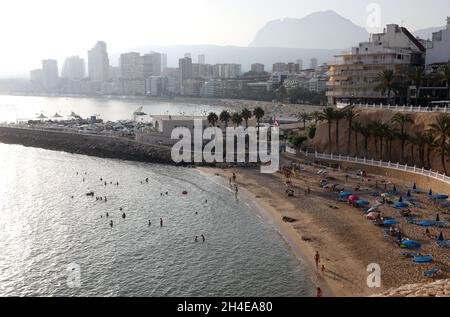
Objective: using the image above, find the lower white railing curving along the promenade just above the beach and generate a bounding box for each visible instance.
[301,151,450,184]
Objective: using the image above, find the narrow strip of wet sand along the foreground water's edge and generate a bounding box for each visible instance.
[195,167,337,297]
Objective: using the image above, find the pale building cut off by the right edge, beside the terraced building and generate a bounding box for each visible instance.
[425,17,450,65]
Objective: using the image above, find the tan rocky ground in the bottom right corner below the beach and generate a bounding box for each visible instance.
[374,280,450,297]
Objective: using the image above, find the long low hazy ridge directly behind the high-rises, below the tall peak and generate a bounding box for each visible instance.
[110,45,341,71]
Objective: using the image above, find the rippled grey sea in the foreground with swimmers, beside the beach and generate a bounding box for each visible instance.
[0,144,314,296]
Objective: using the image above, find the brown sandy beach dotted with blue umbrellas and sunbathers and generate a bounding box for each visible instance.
[200,156,450,296]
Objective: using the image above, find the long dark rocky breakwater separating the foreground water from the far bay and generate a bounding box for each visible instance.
[0,127,173,164]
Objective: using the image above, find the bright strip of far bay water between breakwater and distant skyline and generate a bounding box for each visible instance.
[0,95,223,122]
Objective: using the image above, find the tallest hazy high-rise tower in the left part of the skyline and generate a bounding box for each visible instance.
[88,42,110,82]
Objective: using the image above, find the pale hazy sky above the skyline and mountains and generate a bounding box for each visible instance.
[0,0,450,77]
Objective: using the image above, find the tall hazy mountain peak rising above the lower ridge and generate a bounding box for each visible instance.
[249,10,369,49]
